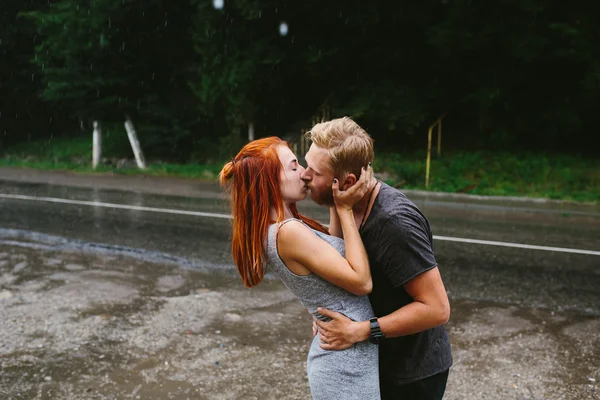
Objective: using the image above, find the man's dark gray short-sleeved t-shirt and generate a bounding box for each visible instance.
[360,183,452,384]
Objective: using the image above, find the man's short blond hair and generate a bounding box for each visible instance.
[306,117,374,178]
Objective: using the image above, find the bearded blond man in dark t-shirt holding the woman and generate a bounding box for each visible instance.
[301,117,452,400]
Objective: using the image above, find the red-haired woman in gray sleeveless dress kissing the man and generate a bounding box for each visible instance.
[219,137,380,400]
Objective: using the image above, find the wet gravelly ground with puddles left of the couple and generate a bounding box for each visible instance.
[0,237,310,399]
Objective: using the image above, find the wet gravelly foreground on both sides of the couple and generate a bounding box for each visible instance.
[0,234,600,400]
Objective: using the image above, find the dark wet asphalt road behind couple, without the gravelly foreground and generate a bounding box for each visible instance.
[0,181,600,315]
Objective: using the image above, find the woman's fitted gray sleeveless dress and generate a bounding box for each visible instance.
[268,219,380,400]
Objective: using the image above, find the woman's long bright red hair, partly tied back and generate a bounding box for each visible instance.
[219,136,328,287]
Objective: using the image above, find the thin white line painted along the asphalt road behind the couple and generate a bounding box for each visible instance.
[0,193,600,256]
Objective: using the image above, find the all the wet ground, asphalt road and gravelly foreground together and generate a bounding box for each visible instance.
[0,172,600,399]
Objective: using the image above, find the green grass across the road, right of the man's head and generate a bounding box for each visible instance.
[375,151,600,202]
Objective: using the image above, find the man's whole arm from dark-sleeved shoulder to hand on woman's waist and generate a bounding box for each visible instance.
[319,205,450,349]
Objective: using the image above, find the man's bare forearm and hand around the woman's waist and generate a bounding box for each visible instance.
[316,267,450,350]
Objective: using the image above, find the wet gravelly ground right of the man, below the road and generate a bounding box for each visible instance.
[447,300,600,399]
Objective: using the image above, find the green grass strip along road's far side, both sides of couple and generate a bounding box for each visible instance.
[0,138,600,203]
